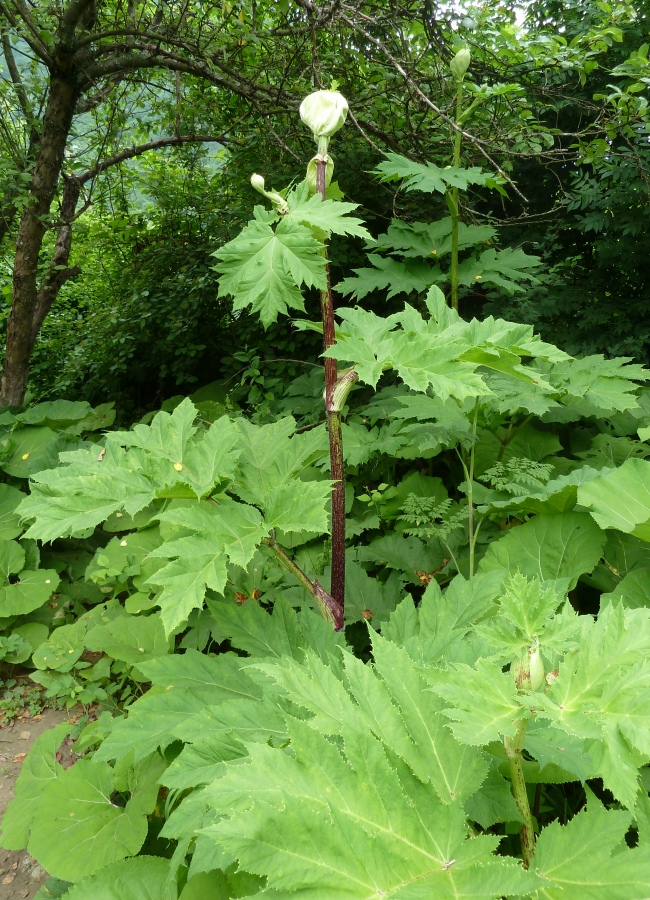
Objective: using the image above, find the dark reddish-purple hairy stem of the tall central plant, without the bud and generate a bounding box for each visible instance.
[316,158,345,609]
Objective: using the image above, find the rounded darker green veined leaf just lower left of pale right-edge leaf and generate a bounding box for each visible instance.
[479,512,606,586]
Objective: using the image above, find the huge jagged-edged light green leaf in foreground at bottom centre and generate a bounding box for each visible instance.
[206,719,535,900]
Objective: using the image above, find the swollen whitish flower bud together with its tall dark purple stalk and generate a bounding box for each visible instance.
[300,91,355,611]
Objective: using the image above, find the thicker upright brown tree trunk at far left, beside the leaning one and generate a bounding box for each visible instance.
[0,68,79,407]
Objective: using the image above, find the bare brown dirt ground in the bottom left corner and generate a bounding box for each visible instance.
[0,709,78,900]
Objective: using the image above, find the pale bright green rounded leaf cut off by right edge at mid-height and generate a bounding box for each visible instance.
[578,459,650,541]
